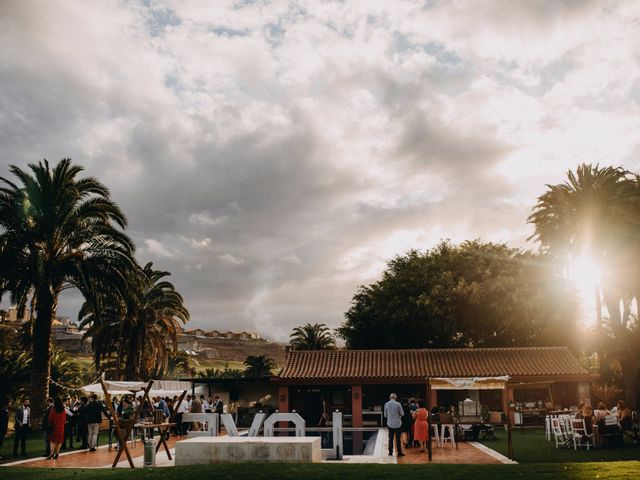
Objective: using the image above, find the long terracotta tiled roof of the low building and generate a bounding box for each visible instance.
[279,347,589,380]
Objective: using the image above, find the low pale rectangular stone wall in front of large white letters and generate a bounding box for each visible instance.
[175,437,322,466]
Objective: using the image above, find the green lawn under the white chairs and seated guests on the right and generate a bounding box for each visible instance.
[482,429,640,463]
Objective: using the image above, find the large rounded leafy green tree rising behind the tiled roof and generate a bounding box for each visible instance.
[338,240,575,348]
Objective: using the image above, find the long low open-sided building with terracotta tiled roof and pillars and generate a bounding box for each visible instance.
[273,347,593,426]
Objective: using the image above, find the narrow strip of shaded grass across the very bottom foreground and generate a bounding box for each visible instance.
[0,462,640,480]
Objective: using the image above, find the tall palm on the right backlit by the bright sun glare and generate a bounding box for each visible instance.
[528,164,640,405]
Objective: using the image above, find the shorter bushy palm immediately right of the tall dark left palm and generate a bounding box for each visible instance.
[80,263,189,379]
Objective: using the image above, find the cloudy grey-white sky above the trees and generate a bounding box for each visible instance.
[0,0,640,340]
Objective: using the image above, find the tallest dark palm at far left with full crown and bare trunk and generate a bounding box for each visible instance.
[0,159,134,422]
